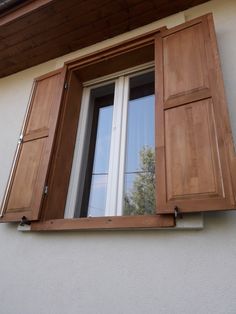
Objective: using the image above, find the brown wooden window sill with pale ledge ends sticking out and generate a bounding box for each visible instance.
[18,213,203,231]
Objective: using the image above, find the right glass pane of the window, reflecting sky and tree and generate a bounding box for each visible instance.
[123,72,155,215]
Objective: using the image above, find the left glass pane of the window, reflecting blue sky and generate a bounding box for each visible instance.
[80,84,114,217]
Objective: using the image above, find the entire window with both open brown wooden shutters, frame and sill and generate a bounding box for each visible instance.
[1,14,236,230]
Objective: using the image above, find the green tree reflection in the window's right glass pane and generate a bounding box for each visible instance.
[124,146,156,215]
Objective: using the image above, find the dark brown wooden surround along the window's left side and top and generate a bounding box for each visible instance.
[42,35,157,221]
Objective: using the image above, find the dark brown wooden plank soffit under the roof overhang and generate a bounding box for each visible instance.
[0,0,206,77]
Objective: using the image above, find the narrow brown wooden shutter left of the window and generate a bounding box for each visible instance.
[1,69,66,221]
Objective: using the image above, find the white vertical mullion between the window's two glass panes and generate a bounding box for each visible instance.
[105,76,125,216]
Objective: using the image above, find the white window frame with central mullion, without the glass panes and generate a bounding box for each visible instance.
[64,62,155,218]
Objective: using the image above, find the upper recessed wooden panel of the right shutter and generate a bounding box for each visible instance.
[163,24,209,107]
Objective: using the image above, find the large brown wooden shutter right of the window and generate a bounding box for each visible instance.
[155,14,235,213]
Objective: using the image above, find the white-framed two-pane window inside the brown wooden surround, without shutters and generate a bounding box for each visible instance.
[66,64,155,218]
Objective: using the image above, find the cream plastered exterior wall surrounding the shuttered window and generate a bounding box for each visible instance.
[0,0,236,314]
